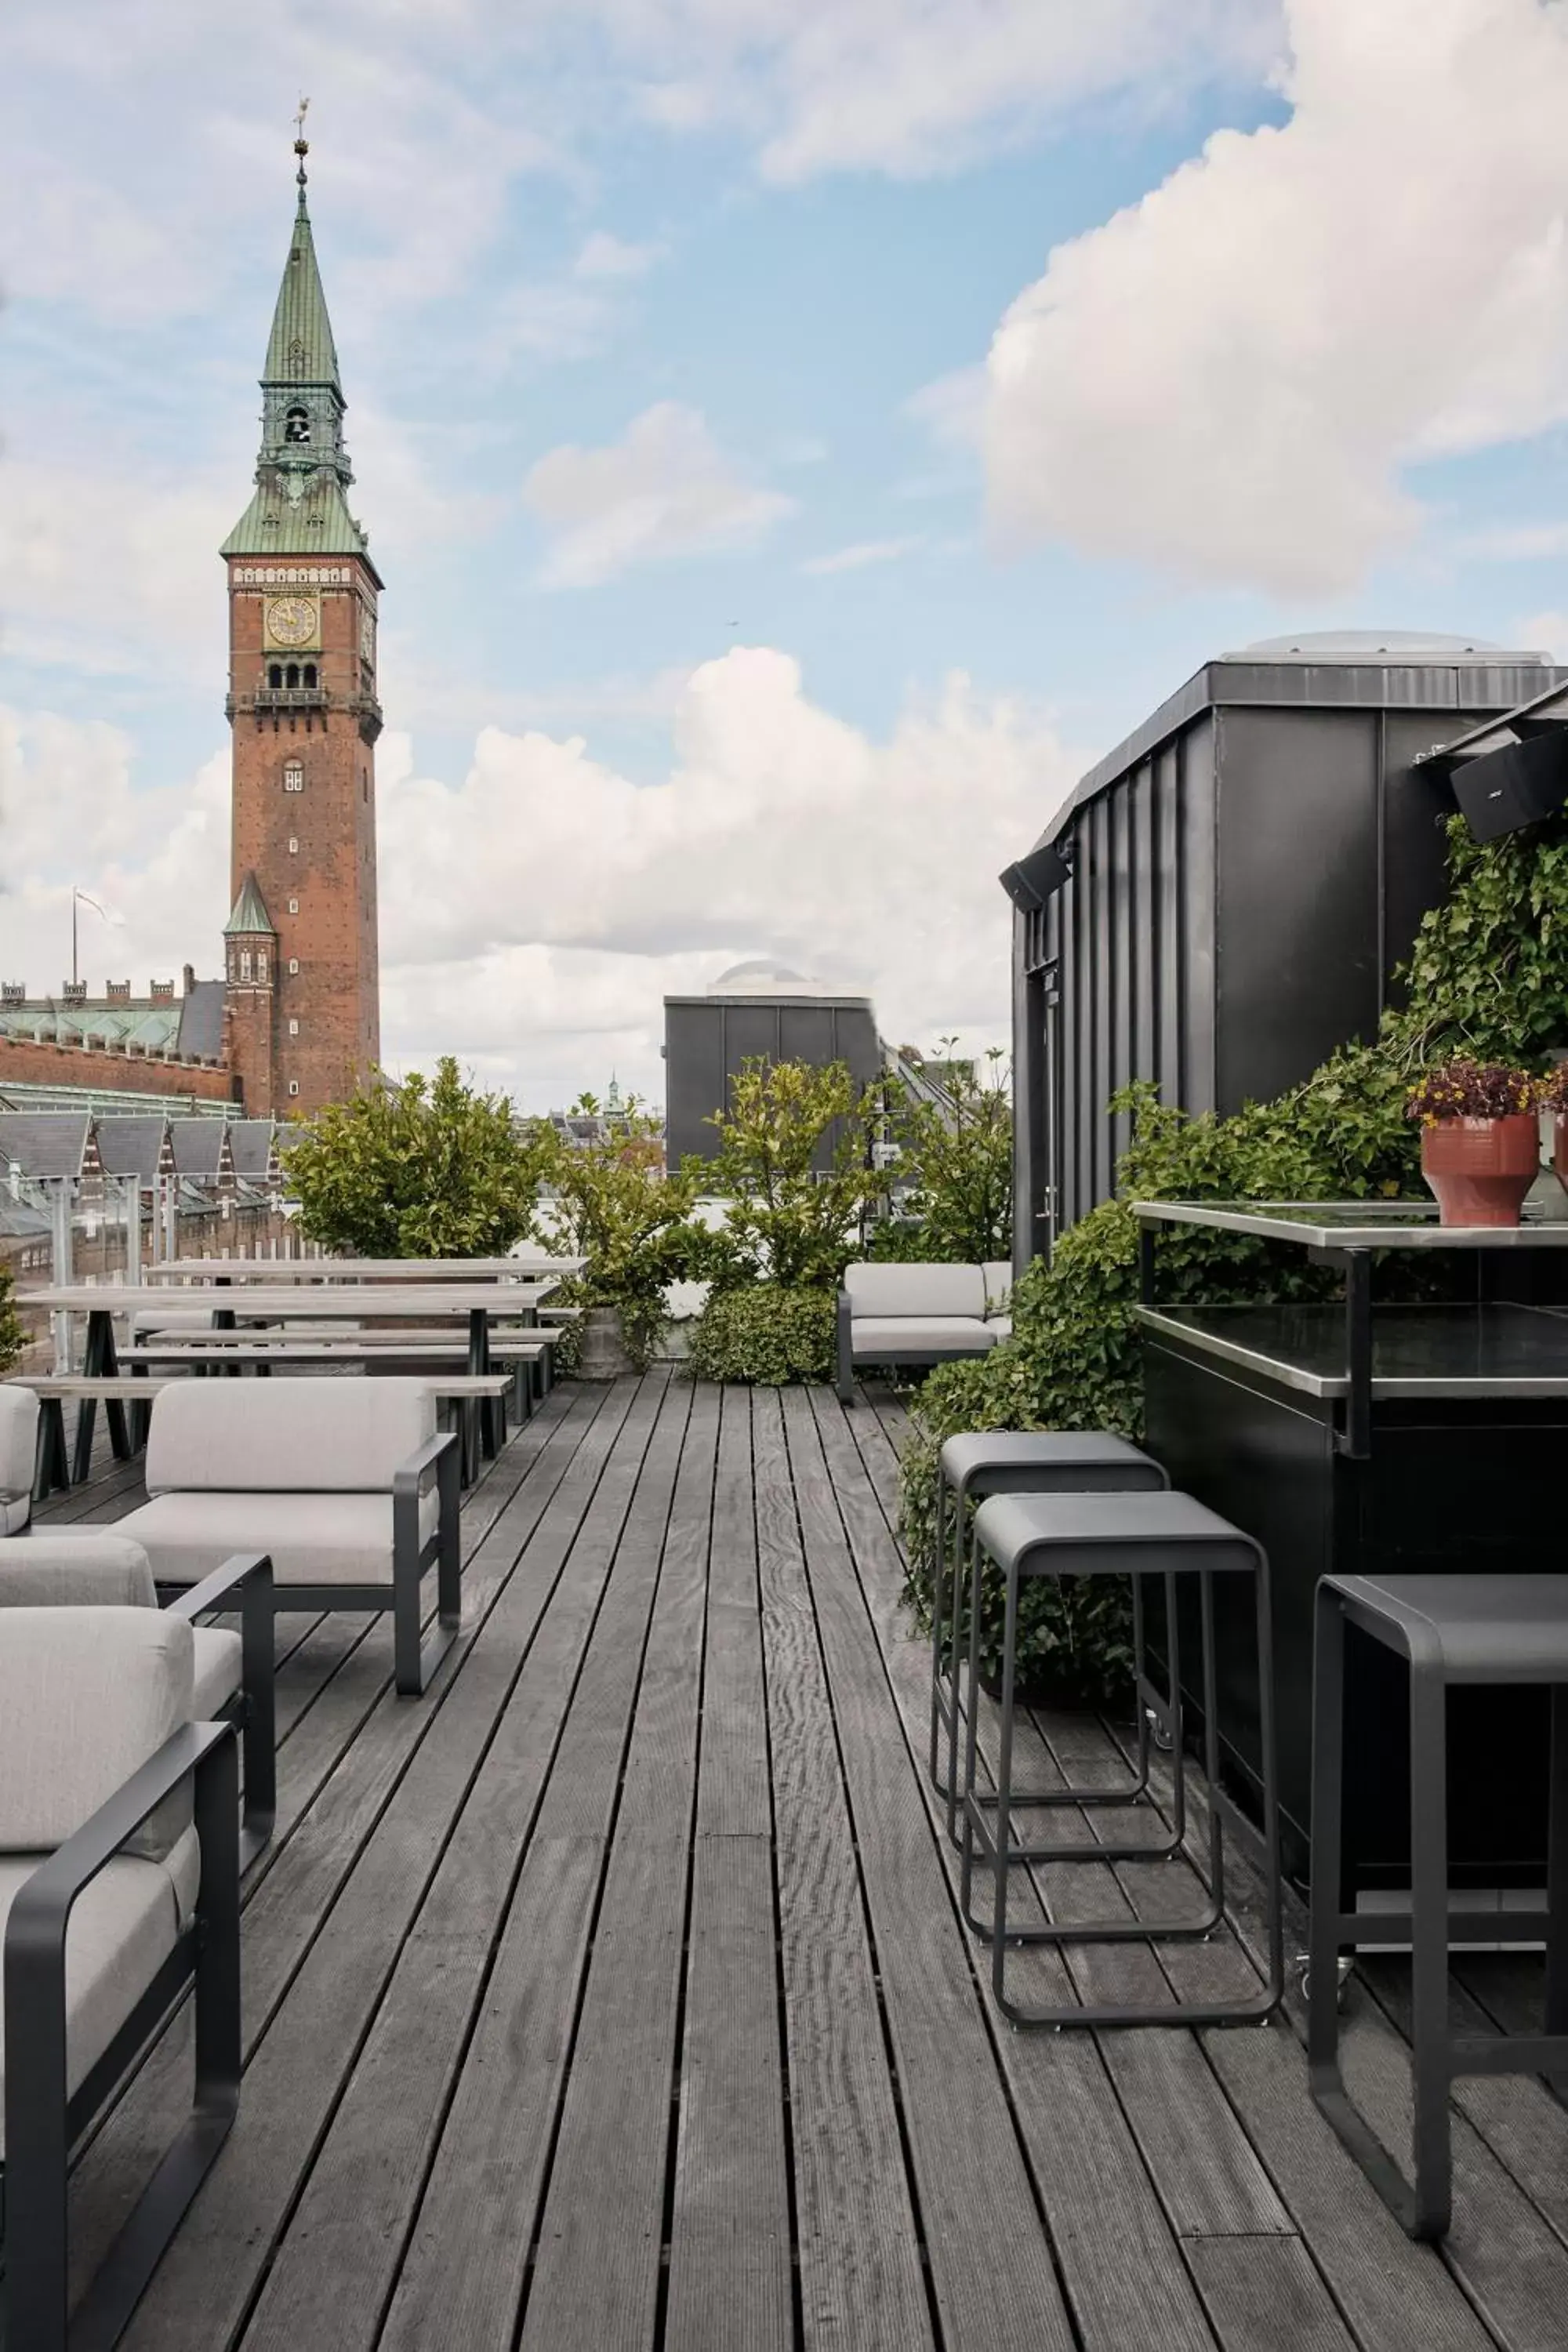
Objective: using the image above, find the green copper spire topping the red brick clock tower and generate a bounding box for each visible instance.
[221,120,378,574]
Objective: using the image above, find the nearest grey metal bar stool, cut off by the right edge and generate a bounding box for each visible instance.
[1307,1576,1568,2239]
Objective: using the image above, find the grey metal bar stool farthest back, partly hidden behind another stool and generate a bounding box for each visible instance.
[931,1430,1166,1846]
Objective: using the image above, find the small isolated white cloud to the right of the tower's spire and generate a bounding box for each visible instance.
[522,400,794,588]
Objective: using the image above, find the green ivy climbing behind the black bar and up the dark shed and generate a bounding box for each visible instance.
[902,816,1568,1703]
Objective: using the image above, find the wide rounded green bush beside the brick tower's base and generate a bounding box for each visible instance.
[282,1056,541,1258]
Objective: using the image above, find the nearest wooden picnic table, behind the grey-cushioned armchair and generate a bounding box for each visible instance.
[26,1289,557,1479]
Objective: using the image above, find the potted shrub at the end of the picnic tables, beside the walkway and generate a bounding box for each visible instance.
[541,1094,696,1381]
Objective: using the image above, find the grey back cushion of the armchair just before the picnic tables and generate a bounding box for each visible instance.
[146,1378,435,1494]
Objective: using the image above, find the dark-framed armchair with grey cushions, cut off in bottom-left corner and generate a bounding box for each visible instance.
[0,1606,240,2352]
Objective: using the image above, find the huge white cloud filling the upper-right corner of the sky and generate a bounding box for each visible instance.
[985,0,1568,595]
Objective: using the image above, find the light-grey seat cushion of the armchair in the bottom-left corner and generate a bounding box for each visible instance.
[0,1830,200,2154]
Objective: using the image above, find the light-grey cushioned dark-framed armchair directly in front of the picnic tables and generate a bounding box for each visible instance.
[115,1378,461,1696]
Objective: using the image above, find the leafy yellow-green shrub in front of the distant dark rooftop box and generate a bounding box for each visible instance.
[687,1058,877,1291]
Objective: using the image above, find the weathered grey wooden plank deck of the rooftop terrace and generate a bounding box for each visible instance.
[34,1374,1568,2352]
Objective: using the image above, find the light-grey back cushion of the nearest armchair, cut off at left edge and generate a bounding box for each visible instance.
[0,1609,195,1853]
